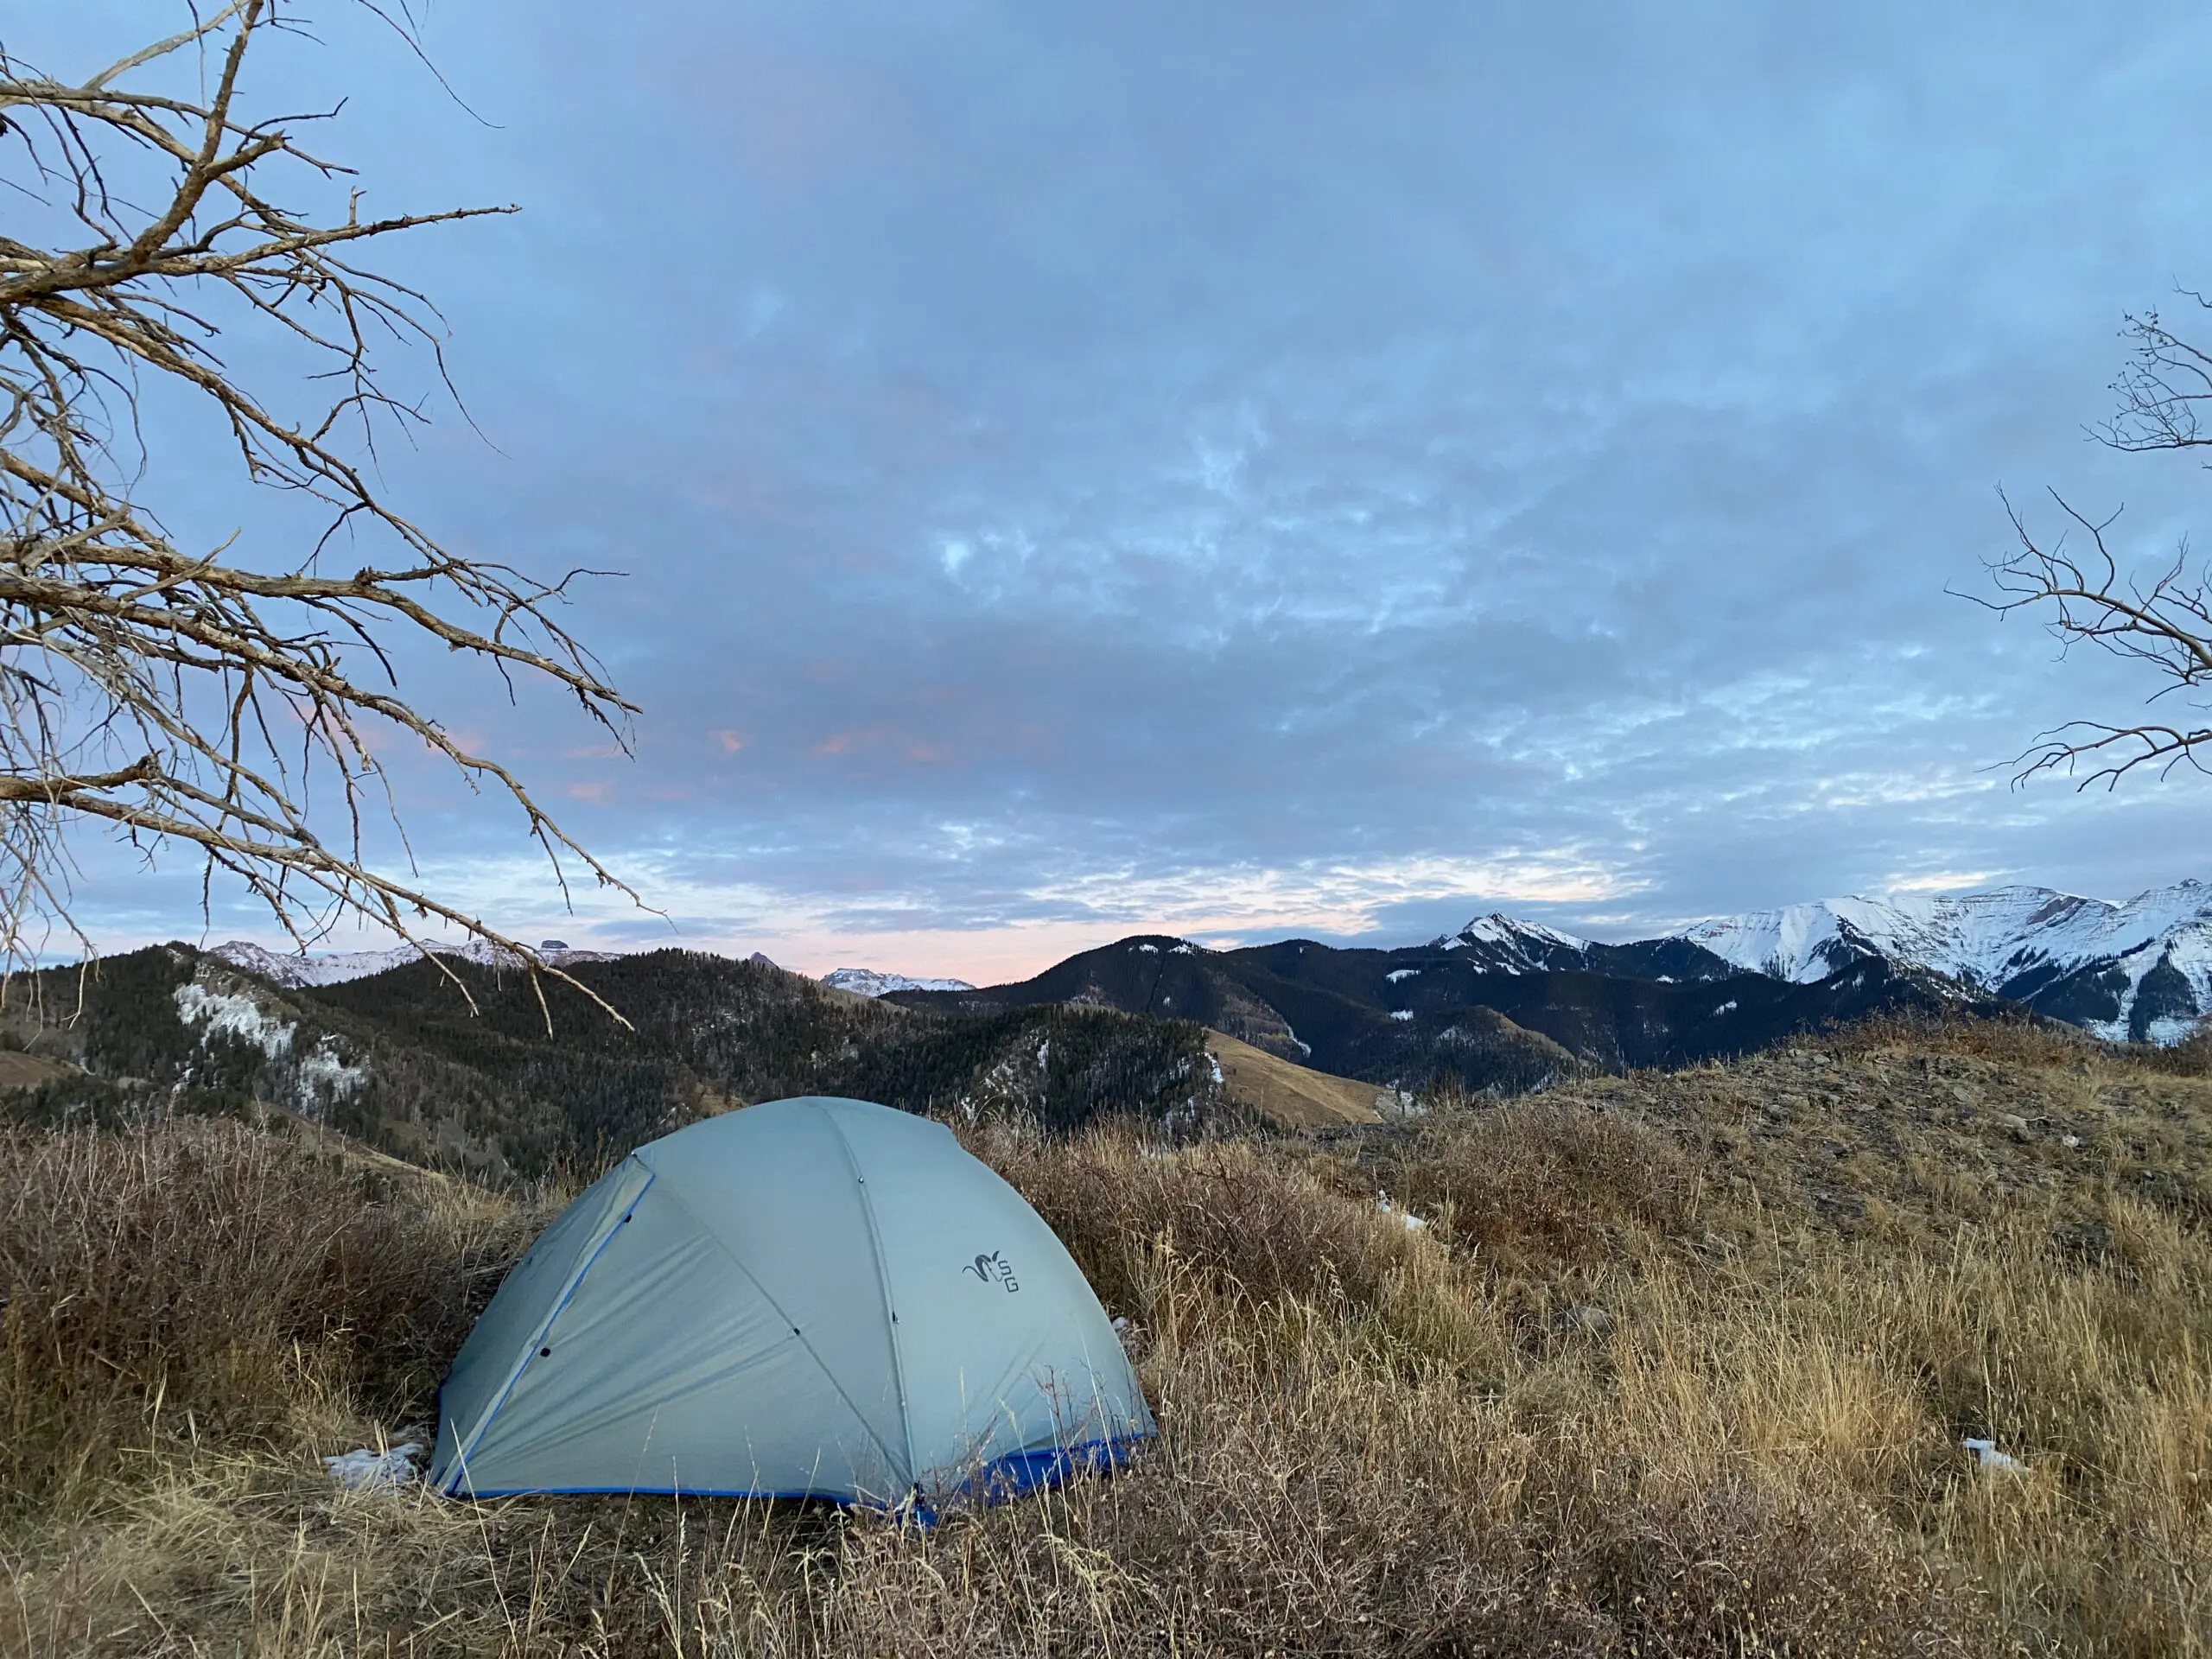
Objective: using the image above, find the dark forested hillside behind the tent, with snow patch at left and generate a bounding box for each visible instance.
[0,944,1415,1181]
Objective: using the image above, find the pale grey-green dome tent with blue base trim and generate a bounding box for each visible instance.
[429,1097,1153,1510]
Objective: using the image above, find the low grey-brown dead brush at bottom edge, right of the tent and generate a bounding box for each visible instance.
[800,1327,1995,1656]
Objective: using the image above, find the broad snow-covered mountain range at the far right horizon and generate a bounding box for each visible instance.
[1675,880,2212,1042]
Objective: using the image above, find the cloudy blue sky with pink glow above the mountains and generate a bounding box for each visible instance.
[7,0,2212,982]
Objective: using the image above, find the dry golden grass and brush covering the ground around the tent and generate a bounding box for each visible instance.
[0,1031,2212,1659]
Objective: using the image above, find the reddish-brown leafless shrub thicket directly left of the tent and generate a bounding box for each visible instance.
[0,1119,522,1500]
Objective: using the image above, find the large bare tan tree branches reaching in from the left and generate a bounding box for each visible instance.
[0,0,637,1018]
